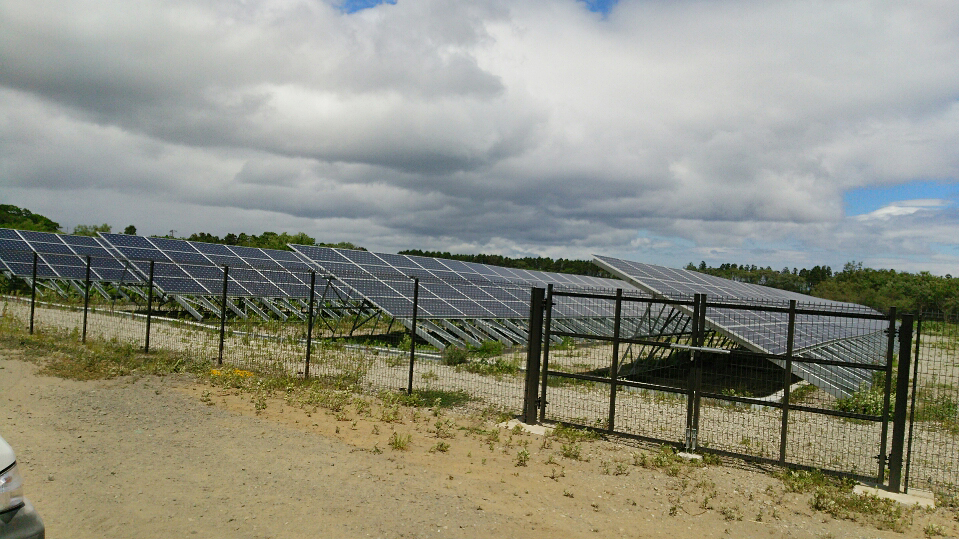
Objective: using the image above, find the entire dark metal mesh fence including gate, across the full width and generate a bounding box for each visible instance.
[2,253,959,496]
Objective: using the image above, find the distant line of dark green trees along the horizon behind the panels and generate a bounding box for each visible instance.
[0,204,959,313]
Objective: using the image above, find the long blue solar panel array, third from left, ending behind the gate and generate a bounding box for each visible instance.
[290,245,632,319]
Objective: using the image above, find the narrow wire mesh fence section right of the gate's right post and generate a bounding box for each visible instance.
[908,313,959,500]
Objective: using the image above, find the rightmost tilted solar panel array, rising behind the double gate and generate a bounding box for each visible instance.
[594,256,888,397]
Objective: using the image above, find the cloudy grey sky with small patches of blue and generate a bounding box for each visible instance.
[0,0,959,275]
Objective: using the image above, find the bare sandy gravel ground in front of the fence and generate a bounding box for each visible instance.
[0,350,959,539]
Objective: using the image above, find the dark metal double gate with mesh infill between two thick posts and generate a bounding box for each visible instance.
[524,287,913,491]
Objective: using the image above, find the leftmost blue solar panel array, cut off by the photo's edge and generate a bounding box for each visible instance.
[0,228,141,283]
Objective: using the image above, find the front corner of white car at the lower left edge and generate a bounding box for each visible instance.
[0,438,46,539]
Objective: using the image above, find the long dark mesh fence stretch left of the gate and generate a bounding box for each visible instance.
[2,254,529,418]
